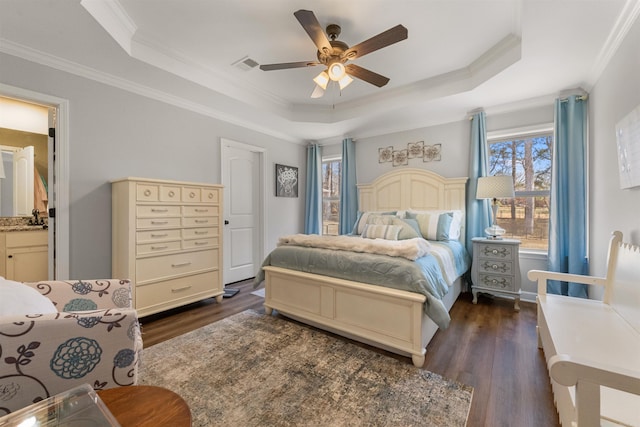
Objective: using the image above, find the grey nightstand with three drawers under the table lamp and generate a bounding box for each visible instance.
[471,237,521,311]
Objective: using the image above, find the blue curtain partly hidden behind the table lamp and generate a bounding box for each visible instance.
[465,111,491,254]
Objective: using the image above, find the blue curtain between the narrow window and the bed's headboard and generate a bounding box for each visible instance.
[340,138,358,234]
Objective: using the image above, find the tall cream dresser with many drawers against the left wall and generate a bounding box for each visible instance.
[111,178,224,316]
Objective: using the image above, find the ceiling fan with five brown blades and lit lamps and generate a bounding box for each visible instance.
[260,9,408,98]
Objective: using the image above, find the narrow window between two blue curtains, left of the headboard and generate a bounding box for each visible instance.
[322,158,342,236]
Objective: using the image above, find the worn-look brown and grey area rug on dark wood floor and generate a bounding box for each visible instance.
[140,310,473,427]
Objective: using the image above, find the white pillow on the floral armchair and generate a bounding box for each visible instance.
[0,276,58,316]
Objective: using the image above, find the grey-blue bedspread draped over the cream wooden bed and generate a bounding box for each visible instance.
[254,241,470,329]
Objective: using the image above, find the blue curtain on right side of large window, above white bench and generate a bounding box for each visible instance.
[547,95,589,298]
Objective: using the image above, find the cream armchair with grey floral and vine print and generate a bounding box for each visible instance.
[0,279,142,416]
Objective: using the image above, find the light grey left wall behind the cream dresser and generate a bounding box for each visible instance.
[0,54,306,278]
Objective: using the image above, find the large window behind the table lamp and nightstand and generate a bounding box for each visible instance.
[487,127,553,252]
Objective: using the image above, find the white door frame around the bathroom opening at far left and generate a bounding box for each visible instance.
[0,83,69,280]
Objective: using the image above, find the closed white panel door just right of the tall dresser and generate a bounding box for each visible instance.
[222,140,262,284]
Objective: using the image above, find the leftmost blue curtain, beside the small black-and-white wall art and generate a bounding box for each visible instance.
[304,144,322,234]
